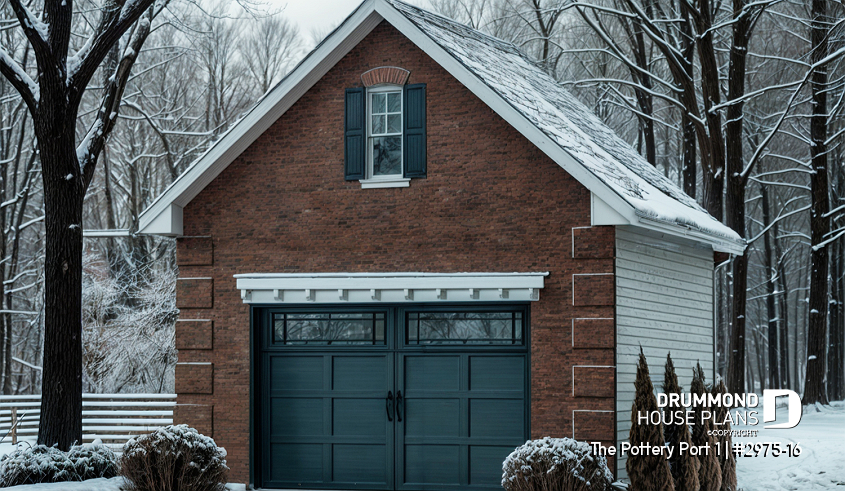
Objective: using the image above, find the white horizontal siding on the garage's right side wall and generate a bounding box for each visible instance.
[616,227,714,478]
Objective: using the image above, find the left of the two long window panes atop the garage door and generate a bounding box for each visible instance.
[273,312,385,346]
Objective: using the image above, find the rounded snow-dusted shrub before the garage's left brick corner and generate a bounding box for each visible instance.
[120,425,229,491]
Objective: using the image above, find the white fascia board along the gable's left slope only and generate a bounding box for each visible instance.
[139,0,382,235]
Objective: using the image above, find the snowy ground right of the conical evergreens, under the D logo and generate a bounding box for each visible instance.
[733,401,845,491]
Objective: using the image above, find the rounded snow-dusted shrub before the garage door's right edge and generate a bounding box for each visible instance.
[502,437,613,491]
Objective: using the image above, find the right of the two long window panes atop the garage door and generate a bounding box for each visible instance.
[405,312,522,345]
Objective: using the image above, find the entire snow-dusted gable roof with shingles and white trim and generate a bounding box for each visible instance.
[139,0,744,253]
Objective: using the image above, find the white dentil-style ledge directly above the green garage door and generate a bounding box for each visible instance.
[235,272,549,304]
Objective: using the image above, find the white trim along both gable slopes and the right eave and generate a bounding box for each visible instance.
[139,0,744,253]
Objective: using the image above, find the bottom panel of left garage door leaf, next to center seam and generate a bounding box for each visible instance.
[332,445,390,486]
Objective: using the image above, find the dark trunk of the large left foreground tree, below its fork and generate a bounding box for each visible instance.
[38,132,85,451]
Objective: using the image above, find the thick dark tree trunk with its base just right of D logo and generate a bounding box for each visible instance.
[802,0,830,404]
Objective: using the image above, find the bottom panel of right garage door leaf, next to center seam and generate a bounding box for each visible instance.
[404,445,461,485]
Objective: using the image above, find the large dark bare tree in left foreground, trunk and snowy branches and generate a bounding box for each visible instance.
[0,0,163,450]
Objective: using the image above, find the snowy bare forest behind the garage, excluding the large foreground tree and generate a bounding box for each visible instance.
[0,0,845,400]
